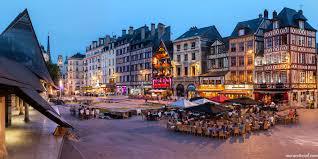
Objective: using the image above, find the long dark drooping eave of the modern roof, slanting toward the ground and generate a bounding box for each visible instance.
[19,87,72,127]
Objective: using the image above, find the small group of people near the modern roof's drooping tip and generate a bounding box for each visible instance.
[70,105,100,120]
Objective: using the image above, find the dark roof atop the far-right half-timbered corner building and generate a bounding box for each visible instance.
[268,7,316,31]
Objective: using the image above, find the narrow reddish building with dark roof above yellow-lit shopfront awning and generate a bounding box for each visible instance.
[222,10,270,98]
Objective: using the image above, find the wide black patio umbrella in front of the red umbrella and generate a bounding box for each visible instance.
[185,103,230,115]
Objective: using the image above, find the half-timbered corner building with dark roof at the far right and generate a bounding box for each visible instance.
[254,8,317,107]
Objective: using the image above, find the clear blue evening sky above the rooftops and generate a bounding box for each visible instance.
[0,0,318,61]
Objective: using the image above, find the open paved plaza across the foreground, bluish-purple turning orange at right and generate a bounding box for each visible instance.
[59,97,318,159]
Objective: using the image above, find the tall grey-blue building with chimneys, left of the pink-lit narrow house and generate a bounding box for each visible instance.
[116,23,170,95]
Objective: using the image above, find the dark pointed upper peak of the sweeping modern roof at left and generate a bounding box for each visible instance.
[0,9,53,84]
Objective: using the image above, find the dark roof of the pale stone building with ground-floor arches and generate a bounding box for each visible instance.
[176,25,222,40]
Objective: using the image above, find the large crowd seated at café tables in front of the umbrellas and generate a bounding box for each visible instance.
[167,106,298,138]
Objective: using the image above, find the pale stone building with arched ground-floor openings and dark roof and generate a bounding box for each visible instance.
[173,26,222,97]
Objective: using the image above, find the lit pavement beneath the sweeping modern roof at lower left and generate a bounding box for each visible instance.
[6,108,62,159]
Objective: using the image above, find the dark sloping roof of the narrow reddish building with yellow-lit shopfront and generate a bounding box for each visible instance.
[231,18,264,38]
